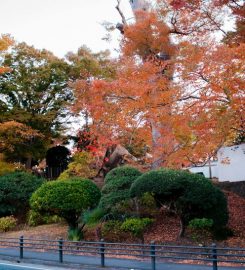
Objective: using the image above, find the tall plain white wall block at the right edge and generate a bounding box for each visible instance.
[218,143,245,182]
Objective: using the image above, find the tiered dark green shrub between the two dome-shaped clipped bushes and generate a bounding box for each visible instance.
[99,166,142,212]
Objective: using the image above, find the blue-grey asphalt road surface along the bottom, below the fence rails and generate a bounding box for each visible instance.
[0,248,245,270]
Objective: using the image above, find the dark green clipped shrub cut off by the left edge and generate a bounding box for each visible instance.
[0,172,44,217]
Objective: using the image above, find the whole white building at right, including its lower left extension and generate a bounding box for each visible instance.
[188,143,245,182]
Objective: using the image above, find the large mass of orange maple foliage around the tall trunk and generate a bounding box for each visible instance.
[74,0,245,167]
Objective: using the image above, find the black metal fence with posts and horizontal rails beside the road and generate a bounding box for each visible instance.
[0,236,245,270]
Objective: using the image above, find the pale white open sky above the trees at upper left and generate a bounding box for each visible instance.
[0,0,132,57]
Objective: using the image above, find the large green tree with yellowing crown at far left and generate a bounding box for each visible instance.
[0,43,72,167]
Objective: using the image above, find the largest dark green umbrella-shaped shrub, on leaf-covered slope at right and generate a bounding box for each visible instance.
[130,169,228,236]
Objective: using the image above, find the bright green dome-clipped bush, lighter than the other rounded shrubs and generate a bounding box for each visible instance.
[30,179,100,228]
